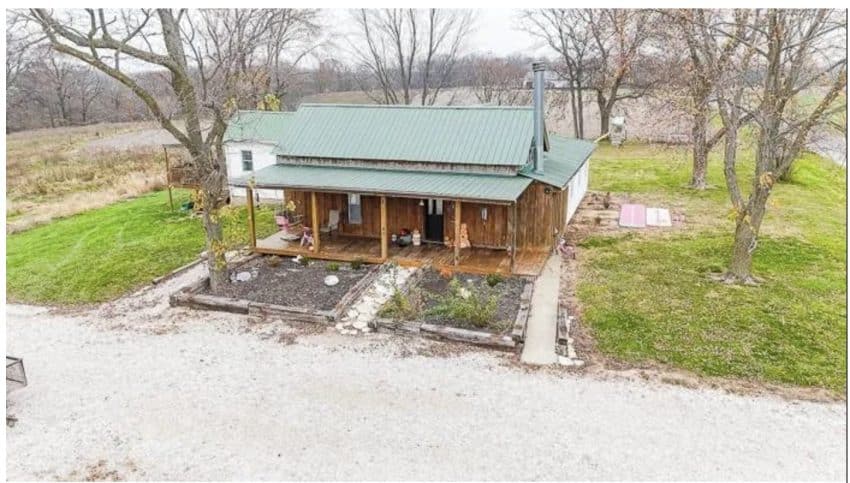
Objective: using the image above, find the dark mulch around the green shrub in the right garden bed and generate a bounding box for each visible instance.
[410,270,527,331]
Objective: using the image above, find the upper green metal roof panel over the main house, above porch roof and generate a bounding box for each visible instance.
[274,104,534,166]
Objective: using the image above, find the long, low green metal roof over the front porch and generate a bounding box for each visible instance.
[231,164,531,202]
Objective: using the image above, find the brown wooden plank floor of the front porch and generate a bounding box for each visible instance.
[255,233,549,277]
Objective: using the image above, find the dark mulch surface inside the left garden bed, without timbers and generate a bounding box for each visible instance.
[201,256,370,310]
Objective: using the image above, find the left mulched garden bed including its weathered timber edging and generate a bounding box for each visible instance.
[171,256,378,323]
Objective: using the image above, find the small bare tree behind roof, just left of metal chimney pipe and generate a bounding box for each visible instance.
[467,56,526,106]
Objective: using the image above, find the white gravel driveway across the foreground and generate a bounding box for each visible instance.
[6,270,846,480]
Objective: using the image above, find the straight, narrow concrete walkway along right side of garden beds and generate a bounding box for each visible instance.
[520,255,561,365]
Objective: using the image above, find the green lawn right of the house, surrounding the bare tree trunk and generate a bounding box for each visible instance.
[578,146,847,394]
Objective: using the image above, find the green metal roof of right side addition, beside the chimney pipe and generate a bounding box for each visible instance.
[519,134,596,188]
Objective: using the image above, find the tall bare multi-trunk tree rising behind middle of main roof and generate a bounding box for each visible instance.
[351,9,472,106]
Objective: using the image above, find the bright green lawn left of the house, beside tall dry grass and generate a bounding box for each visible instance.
[6,191,273,304]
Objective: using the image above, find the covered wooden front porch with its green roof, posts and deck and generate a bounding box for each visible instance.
[235,164,551,275]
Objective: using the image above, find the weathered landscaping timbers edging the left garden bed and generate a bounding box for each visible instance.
[169,257,380,324]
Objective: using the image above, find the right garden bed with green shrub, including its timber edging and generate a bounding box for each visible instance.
[374,270,532,348]
